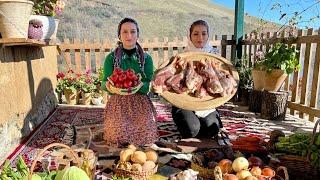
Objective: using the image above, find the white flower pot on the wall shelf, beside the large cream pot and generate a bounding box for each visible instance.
[30,15,59,41]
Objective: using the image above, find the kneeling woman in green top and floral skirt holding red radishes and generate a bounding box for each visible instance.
[102,18,158,146]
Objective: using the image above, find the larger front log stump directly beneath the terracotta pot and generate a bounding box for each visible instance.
[261,91,289,121]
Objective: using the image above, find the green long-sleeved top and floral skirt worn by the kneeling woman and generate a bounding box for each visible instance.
[102,51,158,146]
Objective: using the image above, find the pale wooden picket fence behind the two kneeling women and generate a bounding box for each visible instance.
[59,35,235,72]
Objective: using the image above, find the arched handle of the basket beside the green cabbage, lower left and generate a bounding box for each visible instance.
[28,143,80,180]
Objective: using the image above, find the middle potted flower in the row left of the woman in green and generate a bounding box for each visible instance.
[79,70,96,105]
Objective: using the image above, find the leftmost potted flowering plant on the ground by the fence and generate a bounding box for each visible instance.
[56,70,80,105]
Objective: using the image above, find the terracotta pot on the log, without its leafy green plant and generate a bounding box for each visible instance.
[264,69,287,91]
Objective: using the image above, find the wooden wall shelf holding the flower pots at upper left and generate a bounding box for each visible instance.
[0,38,56,47]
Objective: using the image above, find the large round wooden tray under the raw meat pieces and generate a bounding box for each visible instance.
[161,52,239,111]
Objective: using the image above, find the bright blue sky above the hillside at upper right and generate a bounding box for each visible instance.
[211,0,320,29]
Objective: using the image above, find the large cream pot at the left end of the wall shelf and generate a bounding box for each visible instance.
[0,0,34,38]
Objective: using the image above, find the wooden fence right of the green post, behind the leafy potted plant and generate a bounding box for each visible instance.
[243,29,320,121]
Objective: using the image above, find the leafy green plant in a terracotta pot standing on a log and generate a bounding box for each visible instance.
[252,43,300,91]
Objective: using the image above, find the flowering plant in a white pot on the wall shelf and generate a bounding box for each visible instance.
[30,0,65,40]
